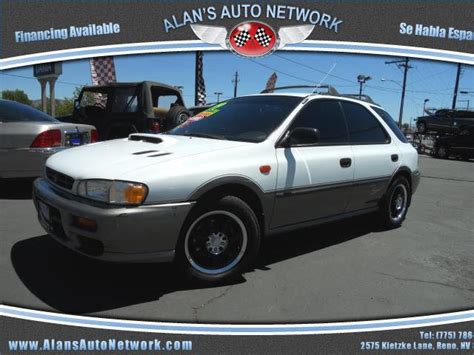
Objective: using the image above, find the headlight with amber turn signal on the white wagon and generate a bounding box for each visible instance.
[77,180,148,205]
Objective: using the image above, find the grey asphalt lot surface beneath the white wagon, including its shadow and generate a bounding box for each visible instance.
[0,156,474,322]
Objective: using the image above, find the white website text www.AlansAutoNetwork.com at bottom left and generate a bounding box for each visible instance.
[8,338,193,352]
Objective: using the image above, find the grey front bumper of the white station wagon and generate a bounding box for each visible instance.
[33,178,194,262]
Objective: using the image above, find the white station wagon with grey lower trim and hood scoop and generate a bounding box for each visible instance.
[34,87,420,282]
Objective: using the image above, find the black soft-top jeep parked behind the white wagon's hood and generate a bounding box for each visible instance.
[61,81,191,140]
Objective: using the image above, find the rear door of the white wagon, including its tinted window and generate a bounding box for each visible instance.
[342,101,400,212]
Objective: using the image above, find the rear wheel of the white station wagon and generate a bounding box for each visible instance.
[379,176,411,229]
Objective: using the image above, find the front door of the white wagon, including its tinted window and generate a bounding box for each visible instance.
[271,99,354,227]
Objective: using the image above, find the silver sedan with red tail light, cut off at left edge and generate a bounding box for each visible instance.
[0,100,97,178]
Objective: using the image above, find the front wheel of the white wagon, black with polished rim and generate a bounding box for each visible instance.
[176,196,261,284]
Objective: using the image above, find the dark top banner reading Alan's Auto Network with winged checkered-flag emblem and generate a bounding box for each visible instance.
[0,0,474,69]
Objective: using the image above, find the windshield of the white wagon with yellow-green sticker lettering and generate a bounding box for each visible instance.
[168,95,302,143]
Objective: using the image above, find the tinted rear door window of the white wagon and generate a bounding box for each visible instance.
[342,101,390,144]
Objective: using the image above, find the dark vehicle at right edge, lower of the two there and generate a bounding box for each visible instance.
[434,127,474,160]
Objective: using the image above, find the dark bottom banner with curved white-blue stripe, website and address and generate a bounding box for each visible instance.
[0,306,474,354]
